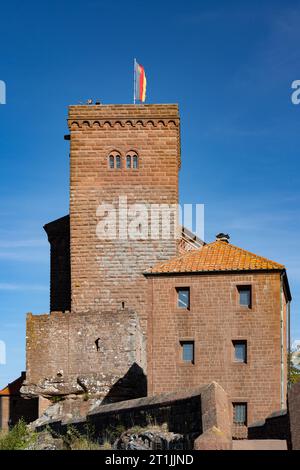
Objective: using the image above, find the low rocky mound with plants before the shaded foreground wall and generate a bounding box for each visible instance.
[113,427,185,450]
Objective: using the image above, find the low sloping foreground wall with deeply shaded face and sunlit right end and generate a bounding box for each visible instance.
[36,383,232,450]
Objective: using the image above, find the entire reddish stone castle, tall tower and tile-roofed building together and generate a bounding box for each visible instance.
[22,104,291,435]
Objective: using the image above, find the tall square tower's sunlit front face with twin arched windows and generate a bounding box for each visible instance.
[68,104,180,329]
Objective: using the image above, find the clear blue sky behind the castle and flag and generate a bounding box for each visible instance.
[0,0,300,387]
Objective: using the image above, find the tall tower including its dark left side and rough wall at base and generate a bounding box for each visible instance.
[22,104,202,403]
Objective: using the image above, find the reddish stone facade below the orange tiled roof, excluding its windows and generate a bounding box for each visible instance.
[148,273,287,437]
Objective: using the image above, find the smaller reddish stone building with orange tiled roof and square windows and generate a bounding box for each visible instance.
[147,234,291,437]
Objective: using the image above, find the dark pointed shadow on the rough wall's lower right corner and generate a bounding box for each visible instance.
[102,362,147,405]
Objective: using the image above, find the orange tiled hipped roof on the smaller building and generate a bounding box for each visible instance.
[145,240,285,274]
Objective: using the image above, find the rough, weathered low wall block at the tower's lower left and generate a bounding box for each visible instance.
[22,309,146,402]
